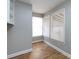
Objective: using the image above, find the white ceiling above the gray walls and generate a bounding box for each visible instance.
[20,0,64,14]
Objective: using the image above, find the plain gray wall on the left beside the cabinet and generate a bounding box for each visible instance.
[7,1,32,55]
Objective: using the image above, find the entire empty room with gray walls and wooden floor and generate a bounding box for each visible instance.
[7,0,71,59]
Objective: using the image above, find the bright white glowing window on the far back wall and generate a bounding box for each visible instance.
[32,17,42,37]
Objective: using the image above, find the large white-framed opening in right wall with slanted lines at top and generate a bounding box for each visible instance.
[51,8,65,42]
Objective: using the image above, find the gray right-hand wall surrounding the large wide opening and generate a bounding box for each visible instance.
[44,0,71,54]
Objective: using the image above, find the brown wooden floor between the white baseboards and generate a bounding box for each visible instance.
[11,42,69,59]
